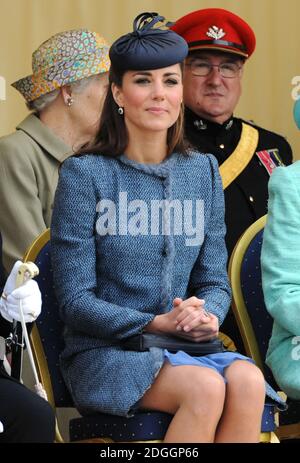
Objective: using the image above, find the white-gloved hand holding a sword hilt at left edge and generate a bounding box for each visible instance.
[0,260,42,323]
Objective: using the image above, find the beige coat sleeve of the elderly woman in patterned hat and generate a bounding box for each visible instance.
[0,134,46,272]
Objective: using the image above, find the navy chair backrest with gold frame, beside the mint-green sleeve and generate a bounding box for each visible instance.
[229,216,278,389]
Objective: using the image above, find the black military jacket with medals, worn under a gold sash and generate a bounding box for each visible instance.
[186,109,292,256]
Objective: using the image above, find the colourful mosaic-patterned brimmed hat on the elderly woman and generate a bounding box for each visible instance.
[12,29,110,102]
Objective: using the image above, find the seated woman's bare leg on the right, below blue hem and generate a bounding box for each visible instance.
[216,360,265,442]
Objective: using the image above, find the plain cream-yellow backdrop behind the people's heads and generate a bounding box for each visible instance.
[0,0,300,159]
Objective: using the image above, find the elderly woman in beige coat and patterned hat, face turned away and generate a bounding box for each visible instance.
[0,29,110,271]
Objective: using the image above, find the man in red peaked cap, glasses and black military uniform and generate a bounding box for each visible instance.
[172,8,292,350]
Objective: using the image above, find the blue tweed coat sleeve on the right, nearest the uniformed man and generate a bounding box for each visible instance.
[189,155,231,325]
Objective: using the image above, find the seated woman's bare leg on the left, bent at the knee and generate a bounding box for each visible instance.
[141,362,225,443]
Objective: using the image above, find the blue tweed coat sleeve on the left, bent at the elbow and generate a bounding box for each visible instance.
[51,155,154,339]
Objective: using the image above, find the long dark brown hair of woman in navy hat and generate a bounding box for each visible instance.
[76,64,187,157]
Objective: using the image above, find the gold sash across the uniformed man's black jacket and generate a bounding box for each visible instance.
[219,122,259,190]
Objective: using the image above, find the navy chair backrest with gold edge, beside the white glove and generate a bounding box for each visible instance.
[24,229,74,407]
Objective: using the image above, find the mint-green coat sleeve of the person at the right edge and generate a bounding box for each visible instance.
[261,164,300,336]
